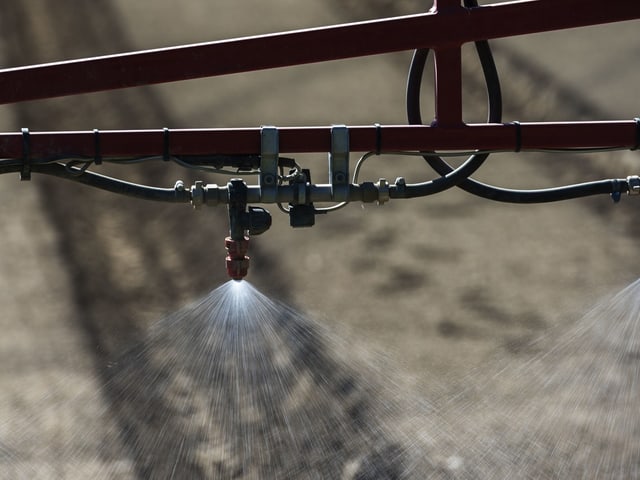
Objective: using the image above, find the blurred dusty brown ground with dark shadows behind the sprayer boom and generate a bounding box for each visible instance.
[0,0,640,478]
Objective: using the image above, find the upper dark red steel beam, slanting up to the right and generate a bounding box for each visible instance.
[0,0,640,104]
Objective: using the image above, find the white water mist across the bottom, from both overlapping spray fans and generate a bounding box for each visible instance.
[0,281,640,480]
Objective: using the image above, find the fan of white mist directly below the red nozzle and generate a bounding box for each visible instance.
[97,281,432,480]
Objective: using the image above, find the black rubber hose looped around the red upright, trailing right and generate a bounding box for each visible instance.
[404,0,626,203]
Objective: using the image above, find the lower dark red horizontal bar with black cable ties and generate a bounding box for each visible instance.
[0,120,639,159]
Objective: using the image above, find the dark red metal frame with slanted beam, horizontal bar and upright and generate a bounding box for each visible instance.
[0,0,640,158]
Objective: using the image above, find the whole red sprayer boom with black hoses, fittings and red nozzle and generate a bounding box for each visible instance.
[0,0,640,280]
